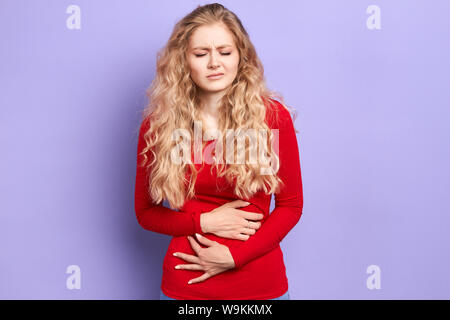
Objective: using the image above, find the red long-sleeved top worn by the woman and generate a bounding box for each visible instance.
[135,100,303,300]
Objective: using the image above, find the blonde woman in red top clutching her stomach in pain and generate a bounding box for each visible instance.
[135,4,303,300]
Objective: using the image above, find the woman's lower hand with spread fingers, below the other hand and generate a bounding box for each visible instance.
[173,234,235,284]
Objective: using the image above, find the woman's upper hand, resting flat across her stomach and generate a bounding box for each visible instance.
[200,200,264,241]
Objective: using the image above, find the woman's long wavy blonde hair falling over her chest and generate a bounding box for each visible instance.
[140,3,295,209]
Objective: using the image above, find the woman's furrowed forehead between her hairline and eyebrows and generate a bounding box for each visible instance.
[189,24,234,49]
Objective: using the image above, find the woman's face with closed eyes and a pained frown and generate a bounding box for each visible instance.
[187,24,239,93]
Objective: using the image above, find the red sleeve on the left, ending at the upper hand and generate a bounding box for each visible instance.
[134,118,201,236]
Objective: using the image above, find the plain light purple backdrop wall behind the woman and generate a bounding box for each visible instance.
[0,0,450,299]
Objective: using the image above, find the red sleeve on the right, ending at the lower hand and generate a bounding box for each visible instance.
[229,104,303,268]
